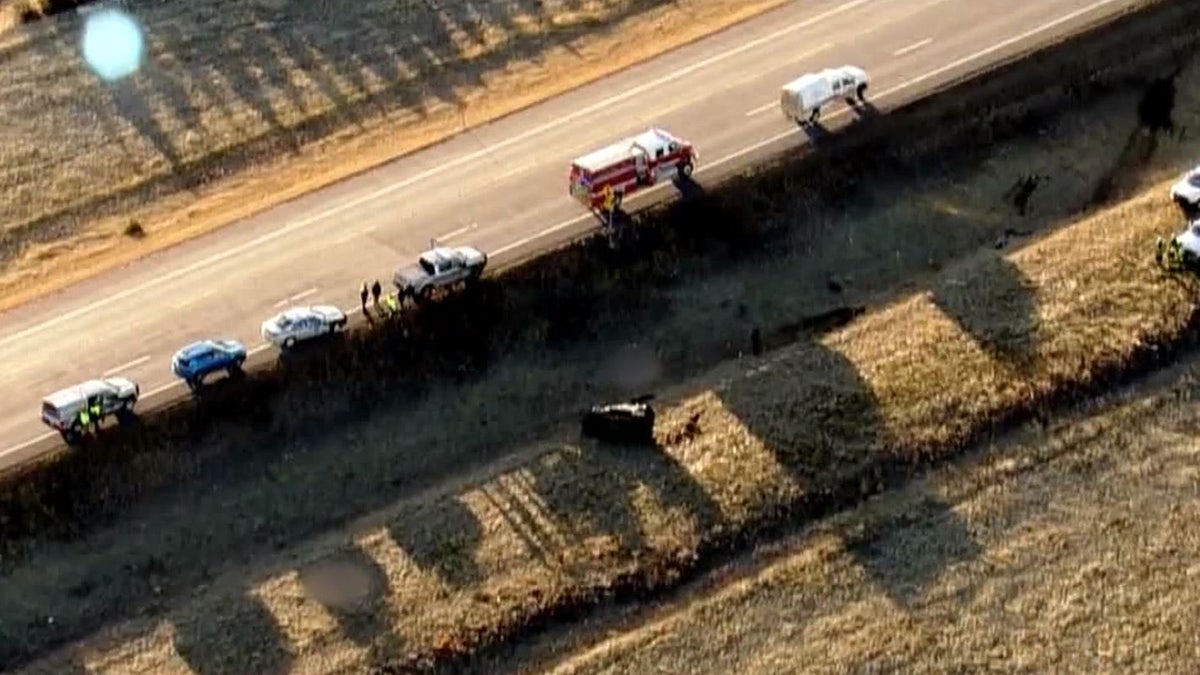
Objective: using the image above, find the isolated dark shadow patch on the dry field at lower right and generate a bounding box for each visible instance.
[846,485,983,610]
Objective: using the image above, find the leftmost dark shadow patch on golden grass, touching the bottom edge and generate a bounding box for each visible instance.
[173,591,293,675]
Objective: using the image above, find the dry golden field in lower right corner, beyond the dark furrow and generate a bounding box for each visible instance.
[528,356,1200,675]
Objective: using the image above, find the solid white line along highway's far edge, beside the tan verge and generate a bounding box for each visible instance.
[0,0,874,347]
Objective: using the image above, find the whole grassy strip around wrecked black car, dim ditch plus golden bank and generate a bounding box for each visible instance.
[11,43,1200,674]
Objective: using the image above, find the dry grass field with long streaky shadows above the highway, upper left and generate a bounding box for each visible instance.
[0,0,784,309]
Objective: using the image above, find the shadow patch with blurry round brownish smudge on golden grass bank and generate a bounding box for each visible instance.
[298,546,401,659]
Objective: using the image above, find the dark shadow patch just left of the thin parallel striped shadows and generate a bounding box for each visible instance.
[388,487,484,589]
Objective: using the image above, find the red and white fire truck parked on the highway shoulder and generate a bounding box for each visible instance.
[569,127,700,210]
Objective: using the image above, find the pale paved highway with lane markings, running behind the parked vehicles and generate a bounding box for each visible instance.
[0,0,1147,466]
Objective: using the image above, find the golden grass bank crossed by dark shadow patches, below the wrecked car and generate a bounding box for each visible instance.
[16,151,1200,673]
